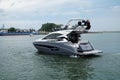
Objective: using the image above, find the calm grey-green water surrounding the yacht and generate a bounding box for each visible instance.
[0,33,120,80]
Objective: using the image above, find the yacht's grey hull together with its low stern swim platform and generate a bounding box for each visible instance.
[33,42,102,55]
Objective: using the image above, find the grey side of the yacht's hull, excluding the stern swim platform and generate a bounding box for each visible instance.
[33,42,75,55]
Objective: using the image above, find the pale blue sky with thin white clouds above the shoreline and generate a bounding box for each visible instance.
[0,0,120,31]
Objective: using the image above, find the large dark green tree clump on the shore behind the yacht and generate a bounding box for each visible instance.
[39,23,62,32]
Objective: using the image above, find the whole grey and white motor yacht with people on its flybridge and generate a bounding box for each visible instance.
[33,19,102,55]
